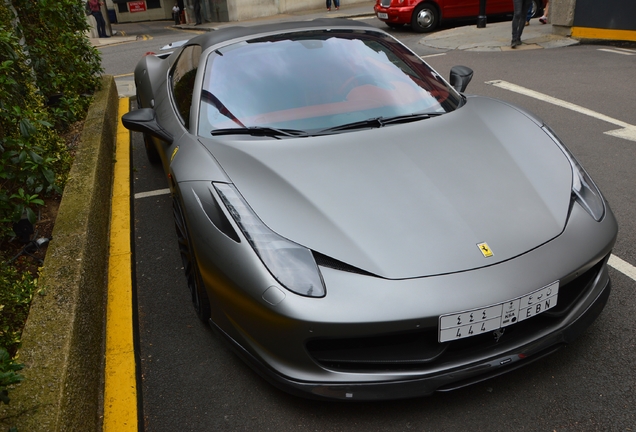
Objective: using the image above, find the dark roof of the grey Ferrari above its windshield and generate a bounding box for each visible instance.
[187,18,378,49]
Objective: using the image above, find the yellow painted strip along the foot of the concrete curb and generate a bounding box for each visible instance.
[103,98,139,432]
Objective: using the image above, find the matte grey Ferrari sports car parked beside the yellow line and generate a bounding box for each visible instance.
[123,19,617,400]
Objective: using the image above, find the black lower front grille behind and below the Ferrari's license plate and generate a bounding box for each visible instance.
[307,255,606,372]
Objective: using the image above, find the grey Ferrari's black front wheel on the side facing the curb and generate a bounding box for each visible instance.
[172,196,210,322]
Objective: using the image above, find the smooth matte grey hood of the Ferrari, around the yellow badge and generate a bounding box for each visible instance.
[204,97,572,279]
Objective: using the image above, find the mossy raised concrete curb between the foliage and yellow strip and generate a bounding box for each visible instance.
[0,76,119,432]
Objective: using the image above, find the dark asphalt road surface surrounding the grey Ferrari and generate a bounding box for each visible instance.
[102,20,636,431]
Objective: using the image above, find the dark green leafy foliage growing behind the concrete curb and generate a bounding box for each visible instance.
[0,0,102,402]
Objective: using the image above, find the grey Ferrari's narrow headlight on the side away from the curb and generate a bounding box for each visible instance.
[542,125,605,221]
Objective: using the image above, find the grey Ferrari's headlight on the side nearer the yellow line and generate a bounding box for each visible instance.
[213,183,325,297]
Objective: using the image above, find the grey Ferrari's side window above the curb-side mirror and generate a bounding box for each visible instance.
[171,45,201,128]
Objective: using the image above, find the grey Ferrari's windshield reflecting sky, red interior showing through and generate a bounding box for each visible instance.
[198,30,460,137]
